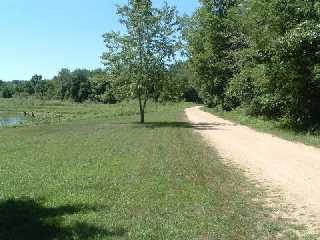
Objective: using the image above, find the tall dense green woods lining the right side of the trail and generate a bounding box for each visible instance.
[184,0,320,128]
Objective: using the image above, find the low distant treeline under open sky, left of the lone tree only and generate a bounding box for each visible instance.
[0,69,115,103]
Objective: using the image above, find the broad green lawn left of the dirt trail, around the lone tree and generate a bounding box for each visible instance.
[0,100,312,240]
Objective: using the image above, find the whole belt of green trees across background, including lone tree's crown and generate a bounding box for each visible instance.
[0,0,320,129]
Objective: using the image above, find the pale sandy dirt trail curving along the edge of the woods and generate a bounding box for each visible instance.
[185,107,320,228]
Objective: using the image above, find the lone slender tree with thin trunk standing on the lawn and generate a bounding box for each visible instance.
[102,0,180,123]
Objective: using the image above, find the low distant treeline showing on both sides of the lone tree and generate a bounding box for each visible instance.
[0,65,199,104]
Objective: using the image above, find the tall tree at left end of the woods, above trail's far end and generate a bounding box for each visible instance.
[185,0,245,106]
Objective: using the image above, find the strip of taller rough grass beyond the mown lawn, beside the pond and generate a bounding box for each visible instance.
[0,98,170,125]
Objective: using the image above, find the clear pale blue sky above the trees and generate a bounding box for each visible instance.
[0,0,198,80]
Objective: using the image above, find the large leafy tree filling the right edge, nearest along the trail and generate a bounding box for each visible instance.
[238,0,320,127]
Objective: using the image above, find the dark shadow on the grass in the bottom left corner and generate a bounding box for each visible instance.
[0,198,126,240]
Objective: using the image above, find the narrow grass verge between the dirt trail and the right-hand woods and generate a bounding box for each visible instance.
[203,107,320,147]
